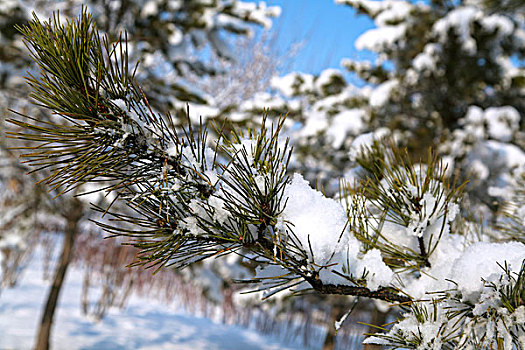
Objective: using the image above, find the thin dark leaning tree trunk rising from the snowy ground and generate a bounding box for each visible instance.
[35,199,83,350]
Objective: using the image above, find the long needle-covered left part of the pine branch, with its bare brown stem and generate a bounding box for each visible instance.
[11,11,420,302]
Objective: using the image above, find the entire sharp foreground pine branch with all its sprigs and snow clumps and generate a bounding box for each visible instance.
[11,12,525,349]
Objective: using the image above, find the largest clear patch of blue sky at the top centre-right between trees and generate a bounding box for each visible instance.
[258,0,374,74]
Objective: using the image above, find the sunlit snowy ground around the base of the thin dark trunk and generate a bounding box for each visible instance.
[0,252,301,350]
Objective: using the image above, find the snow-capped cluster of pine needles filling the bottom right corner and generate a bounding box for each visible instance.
[365,246,525,349]
